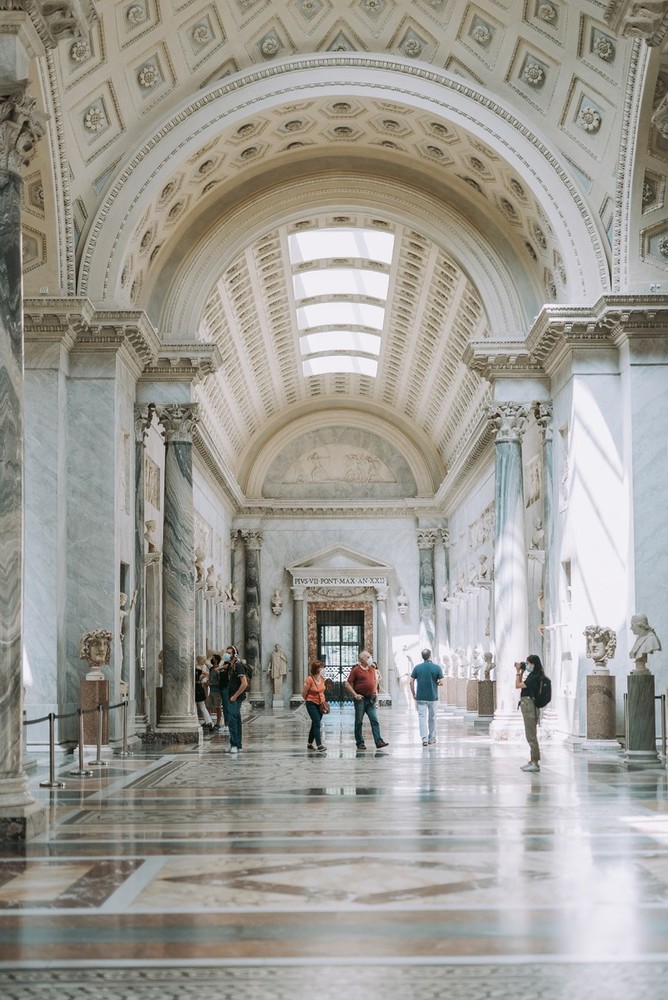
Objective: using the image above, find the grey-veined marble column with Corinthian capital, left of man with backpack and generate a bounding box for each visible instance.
[156,403,200,743]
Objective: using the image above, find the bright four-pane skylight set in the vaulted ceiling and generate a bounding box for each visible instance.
[288,228,394,378]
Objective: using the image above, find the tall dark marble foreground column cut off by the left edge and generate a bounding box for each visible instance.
[0,84,45,840]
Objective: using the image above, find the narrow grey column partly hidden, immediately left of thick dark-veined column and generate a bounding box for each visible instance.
[134,406,153,732]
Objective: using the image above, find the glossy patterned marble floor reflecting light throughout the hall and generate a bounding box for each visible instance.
[0,706,668,1000]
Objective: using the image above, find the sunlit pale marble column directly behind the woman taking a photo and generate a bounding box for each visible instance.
[488,402,529,740]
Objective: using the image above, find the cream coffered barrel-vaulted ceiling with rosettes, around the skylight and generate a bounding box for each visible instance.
[24,0,665,508]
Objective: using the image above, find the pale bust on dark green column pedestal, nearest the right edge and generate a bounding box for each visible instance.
[624,615,661,766]
